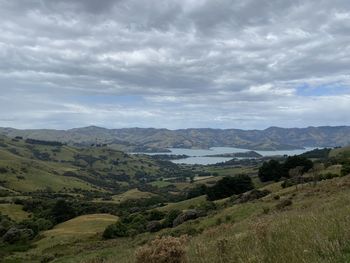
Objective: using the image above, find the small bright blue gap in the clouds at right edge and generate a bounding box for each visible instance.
[296,83,350,97]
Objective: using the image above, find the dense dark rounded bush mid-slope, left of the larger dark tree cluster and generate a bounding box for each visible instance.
[207,175,254,201]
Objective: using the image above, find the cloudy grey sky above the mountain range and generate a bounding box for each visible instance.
[0,0,350,129]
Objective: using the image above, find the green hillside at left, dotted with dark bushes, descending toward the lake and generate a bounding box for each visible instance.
[0,136,177,193]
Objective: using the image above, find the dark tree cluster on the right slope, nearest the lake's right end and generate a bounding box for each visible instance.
[258,155,313,182]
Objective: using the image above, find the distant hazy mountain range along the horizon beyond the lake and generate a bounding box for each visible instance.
[0,126,350,152]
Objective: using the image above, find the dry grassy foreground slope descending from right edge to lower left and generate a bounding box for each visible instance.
[6,176,350,263]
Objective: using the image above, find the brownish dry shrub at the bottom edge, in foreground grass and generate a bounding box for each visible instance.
[136,236,188,263]
